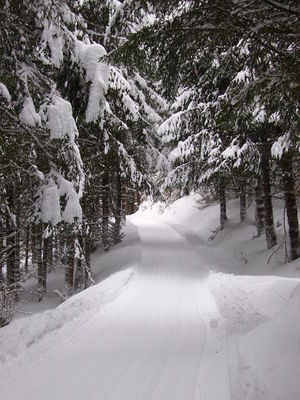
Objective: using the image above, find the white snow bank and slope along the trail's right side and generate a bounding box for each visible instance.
[133,195,300,400]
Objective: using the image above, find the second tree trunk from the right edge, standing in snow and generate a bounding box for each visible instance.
[260,145,277,249]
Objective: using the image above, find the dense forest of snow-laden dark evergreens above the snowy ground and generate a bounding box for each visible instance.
[0,0,300,324]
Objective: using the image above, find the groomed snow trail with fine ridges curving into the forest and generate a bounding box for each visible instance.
[1,220,231,400]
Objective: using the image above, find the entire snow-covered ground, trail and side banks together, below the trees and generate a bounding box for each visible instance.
[0,196,300,400]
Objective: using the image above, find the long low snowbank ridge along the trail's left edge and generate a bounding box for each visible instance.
[0,268,134,371]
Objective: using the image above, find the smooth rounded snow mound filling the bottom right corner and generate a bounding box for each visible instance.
[238,285,300,400]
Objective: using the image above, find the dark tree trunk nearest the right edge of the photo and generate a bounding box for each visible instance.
[280,155,300,260]
